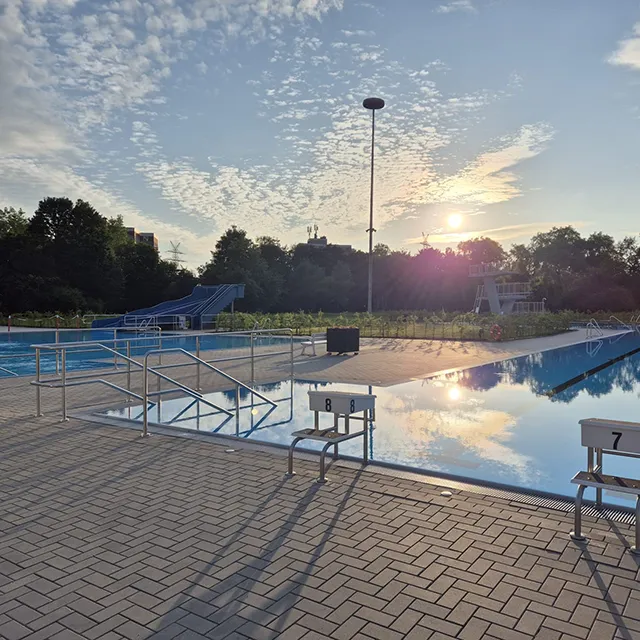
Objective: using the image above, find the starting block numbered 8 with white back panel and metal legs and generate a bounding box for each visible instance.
[287,391,376,484]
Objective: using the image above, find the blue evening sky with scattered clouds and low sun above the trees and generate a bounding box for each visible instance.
[0,0,640,267]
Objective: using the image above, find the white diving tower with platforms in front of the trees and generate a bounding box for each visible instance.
[469,262,544,315]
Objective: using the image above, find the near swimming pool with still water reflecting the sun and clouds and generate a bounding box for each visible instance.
[102,333,640,505]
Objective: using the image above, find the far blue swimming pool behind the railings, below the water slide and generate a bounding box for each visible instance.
[0,329,302,378]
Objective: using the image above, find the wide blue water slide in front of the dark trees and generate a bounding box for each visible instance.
[91,284,244,329]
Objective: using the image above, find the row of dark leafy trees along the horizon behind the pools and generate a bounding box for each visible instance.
[0,198,640,315]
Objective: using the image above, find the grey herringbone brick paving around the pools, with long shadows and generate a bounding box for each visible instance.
[0,336,640,640]
